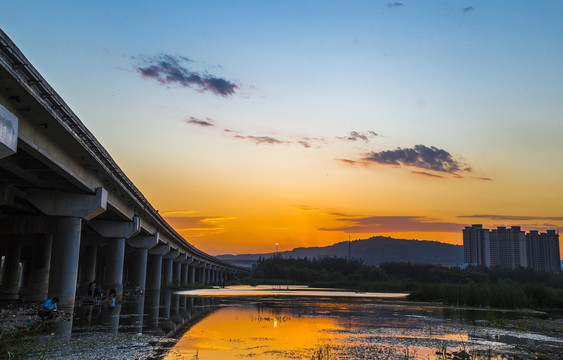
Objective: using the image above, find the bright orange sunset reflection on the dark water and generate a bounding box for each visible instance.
[165,307,341,360]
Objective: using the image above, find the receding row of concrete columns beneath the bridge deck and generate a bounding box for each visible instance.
[0,188,239,310]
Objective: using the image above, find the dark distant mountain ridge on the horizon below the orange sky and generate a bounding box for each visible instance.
[217,236,463,265]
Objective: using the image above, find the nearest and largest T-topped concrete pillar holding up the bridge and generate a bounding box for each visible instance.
[27,188,108,311]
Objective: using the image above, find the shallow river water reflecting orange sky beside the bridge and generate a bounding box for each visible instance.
[37,286,563,360]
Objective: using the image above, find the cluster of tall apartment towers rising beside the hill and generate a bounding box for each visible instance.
[463,225,561,272]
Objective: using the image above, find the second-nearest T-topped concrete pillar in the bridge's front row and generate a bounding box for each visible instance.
[89,216,141,295]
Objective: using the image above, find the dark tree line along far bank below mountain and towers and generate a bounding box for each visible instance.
[248,255,563,309]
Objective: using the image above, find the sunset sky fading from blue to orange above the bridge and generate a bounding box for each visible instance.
[0,0,563,255]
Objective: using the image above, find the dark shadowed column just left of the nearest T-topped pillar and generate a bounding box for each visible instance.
[23,234,53,301]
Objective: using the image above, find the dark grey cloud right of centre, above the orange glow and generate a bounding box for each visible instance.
[362,145,471,173]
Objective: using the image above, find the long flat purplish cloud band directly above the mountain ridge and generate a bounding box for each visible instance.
[319,216,466,234]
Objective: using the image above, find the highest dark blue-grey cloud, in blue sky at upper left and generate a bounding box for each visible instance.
[135,55,238,97]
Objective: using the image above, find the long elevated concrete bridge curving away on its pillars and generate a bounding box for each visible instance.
[0,30,247,309]
